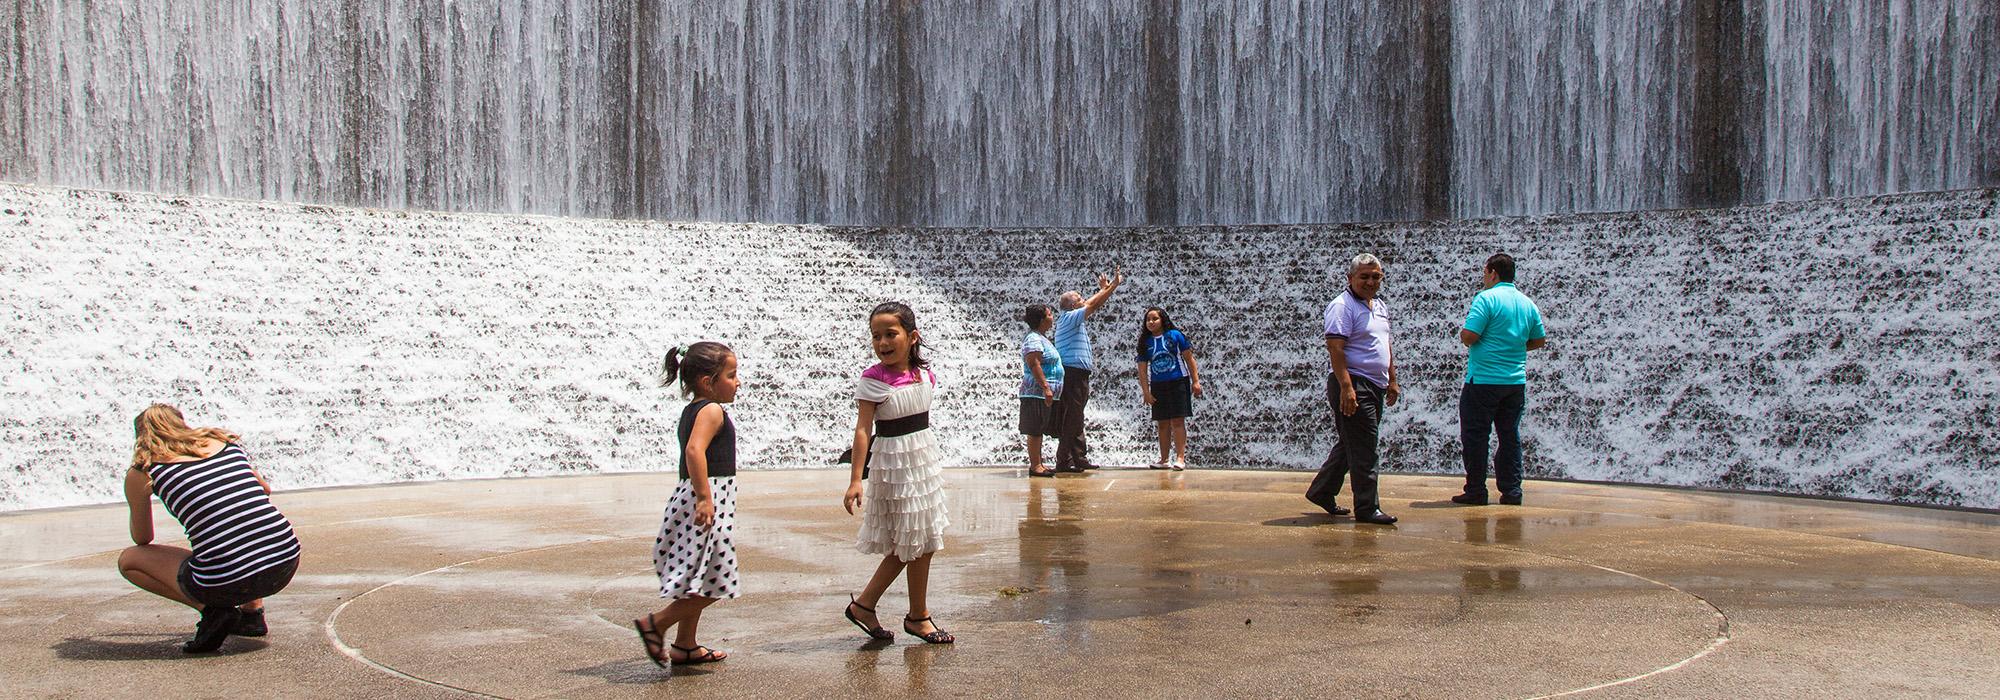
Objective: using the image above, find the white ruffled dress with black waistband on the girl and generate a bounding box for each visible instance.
[854,364,952,562]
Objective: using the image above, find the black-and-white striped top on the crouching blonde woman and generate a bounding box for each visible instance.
[148,444,298,588]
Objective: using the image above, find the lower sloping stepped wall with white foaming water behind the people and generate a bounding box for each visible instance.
[0,184,2000,510]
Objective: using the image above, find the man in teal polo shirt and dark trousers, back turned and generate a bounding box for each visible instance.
[1452,252,1546,506]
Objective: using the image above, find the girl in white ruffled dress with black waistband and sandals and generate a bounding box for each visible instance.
[840,302,954,644]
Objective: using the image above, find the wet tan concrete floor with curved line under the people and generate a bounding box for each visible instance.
[0,468,2000,700]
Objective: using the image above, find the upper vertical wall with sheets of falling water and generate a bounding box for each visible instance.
[0,0,2000,226]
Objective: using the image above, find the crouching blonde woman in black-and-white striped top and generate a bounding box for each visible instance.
[118,404,298,654]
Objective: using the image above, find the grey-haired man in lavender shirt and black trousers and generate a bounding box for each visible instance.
[1306,252,1402,524]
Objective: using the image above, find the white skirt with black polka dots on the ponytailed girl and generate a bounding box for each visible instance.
[652,476,742,600]
